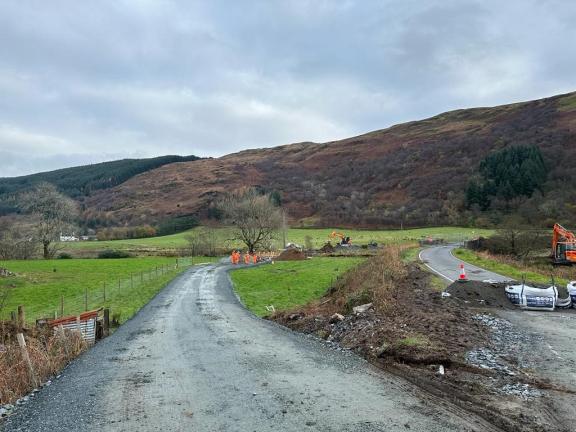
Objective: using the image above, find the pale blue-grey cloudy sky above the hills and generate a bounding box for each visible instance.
[0,0,576,177]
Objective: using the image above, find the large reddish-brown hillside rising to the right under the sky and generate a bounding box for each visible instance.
[80,93,576,227]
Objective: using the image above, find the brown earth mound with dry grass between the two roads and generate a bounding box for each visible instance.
[272,251,486,365]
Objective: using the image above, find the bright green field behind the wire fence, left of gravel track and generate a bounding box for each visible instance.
[0,257,214,321]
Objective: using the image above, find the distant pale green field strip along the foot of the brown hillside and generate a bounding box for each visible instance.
[66,227,493,252]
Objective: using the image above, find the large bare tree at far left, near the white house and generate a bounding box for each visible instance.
[20,183,78,259]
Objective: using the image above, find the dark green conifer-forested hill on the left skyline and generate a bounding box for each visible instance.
[0,156,199,204]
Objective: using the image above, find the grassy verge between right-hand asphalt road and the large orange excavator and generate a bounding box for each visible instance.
[454,249,572,285]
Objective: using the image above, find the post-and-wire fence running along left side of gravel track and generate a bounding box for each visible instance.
[4,257,201,323]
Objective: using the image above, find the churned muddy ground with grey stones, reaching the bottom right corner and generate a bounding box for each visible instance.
[271,264,576,431]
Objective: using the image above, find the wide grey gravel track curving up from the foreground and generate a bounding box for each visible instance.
[0,265,500,432]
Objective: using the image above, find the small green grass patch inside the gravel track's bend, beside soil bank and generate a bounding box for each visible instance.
[230,258,363,316]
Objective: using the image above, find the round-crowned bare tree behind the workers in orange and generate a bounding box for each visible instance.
[218,189,282,253]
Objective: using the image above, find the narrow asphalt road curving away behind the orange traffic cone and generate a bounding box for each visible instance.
[420,245,510,282]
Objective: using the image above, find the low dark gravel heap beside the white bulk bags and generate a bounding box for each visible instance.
[446,281,517,309]
